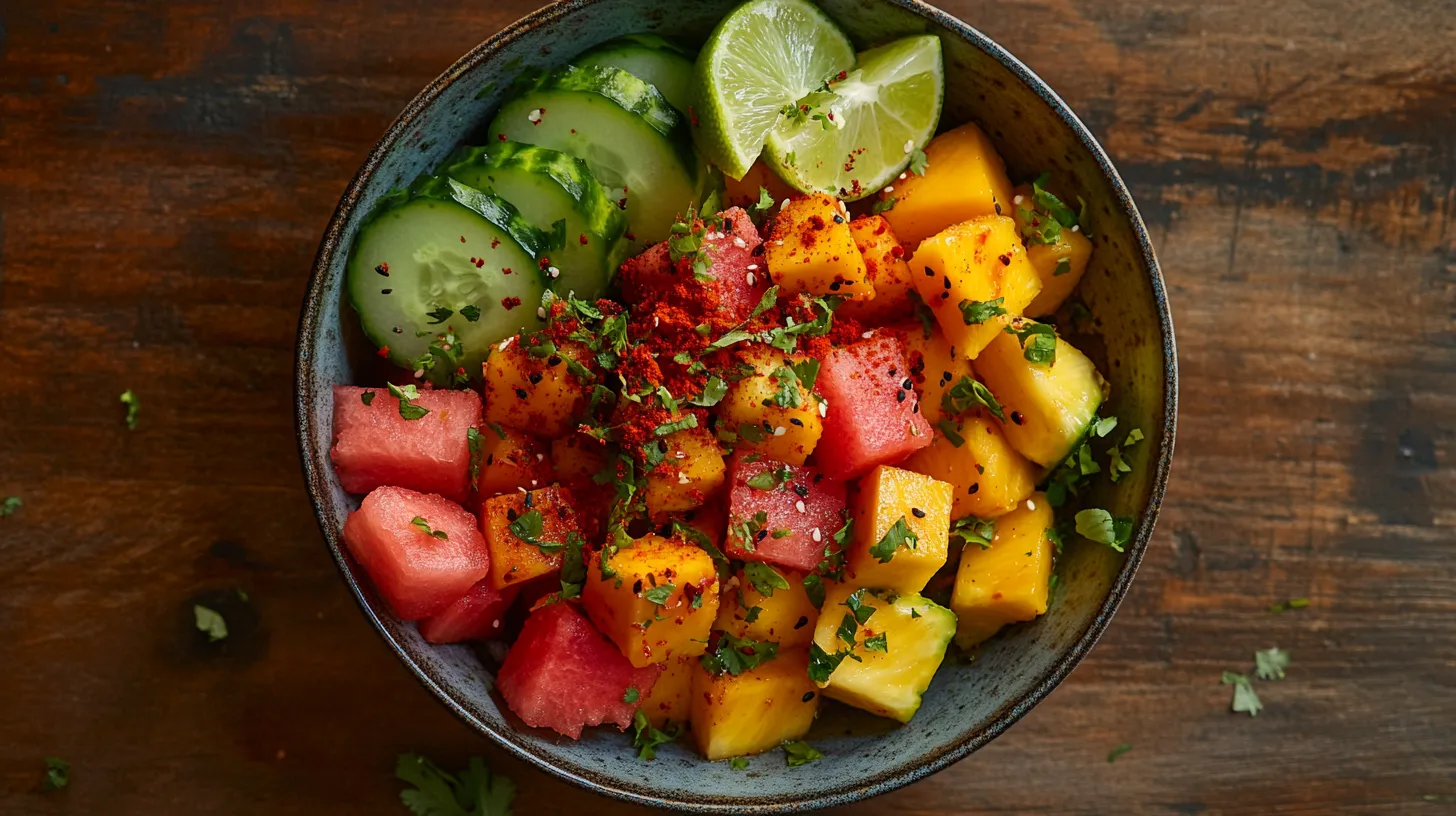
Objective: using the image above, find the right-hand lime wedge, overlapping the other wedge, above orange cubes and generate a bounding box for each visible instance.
[766,35,945,201]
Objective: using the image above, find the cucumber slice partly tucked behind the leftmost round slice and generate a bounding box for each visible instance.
[440,141,628,300]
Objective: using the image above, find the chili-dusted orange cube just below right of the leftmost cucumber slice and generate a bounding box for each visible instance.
[483,337,587,439]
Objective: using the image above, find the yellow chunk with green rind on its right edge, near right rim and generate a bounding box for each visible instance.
[976,321,1105,468]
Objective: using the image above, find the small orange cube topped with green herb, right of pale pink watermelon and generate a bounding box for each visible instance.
[480,487,584,589]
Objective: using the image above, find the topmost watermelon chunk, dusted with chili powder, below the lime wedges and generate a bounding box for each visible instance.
[619,207,770,321]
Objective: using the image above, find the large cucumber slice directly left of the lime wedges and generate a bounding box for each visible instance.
[488,66,706,249]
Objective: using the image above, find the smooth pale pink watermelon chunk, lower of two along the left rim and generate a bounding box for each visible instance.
[344,487,491,621]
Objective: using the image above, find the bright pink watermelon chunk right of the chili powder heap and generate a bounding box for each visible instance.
[814,332,932,479]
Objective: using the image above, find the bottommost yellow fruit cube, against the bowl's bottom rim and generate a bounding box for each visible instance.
[692,648,820,759]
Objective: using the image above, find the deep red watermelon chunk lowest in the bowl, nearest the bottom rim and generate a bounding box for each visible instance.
[495,602,662,739]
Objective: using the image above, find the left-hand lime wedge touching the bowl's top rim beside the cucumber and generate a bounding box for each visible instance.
[693,0,850,179]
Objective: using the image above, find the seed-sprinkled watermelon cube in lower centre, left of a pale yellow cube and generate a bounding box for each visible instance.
[727,456,844,571]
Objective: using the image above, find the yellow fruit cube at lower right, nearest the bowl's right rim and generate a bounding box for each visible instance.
[951,493,1056,648]
